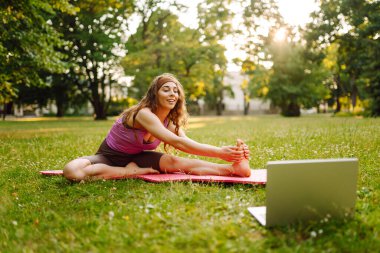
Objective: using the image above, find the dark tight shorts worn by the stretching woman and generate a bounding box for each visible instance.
[80,140,163,170]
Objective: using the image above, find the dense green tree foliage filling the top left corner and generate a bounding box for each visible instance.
[0,0,77,118]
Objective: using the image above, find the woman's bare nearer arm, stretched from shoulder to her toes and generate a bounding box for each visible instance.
[136,108,244,162]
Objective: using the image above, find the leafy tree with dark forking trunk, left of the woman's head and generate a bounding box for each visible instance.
[52,0,133,120]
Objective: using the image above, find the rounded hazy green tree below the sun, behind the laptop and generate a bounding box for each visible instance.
[267,29,327,116]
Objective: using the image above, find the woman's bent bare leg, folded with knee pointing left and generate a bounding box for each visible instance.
[63,158,159,181]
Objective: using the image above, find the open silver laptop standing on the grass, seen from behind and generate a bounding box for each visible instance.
[248,158,358,226]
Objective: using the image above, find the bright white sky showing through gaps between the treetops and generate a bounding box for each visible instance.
[179,0,318,71]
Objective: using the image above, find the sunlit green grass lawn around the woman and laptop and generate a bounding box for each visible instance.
[0,116,380,252]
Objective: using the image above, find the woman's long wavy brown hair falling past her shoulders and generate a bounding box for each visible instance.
[121,73,188,138]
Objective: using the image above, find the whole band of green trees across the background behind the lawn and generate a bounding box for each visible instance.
[0,0,380,119]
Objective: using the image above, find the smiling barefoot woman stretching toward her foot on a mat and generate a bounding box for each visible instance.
[63,74,251,181]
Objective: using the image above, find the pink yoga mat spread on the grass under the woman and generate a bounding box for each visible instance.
[40,169,267,184]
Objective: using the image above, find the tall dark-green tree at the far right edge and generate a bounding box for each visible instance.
[308,0,380,116]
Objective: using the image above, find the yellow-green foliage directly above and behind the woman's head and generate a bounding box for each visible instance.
[122,1,231,114]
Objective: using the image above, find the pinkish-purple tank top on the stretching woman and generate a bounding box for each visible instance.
[106,117,169,154]
